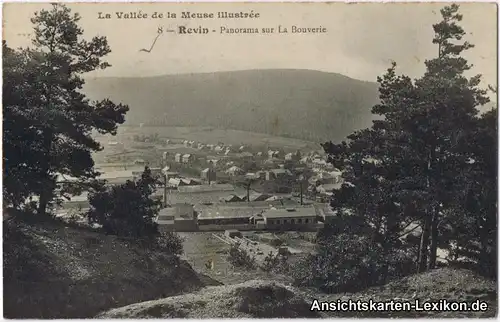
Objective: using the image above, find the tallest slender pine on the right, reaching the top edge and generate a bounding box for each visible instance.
[415,4,488,270]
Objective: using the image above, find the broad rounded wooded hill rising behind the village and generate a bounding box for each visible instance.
[84,69,378,142]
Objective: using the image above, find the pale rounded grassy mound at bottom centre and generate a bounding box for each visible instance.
[98,280,321,319]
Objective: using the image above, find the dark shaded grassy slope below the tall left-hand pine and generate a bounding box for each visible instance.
[3,215,219,318]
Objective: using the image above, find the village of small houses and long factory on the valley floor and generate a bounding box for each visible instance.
[53,127,342,269]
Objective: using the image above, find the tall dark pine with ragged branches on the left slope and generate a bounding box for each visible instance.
[4,4,128,214]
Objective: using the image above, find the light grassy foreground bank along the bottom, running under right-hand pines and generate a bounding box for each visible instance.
[97,268,497,319]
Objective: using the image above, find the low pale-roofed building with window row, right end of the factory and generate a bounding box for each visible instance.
[262,207,318,229]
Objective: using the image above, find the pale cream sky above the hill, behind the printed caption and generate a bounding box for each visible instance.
[3,3,497,86]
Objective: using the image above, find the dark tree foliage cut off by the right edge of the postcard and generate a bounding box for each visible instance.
[447,109,498,276]
